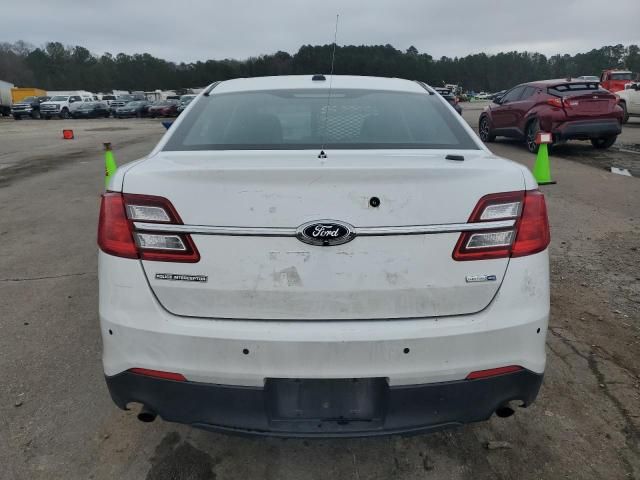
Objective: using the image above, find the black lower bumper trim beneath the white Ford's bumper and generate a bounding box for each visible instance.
[106,370,542,437]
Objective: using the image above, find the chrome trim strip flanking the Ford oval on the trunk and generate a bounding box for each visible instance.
[133,219,516,237]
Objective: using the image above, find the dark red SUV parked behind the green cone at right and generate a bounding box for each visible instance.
[479,79,623,153]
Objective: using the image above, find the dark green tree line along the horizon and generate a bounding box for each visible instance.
[0,41,640,92]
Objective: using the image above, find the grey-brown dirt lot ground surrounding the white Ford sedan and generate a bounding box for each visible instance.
[0,116,640,480]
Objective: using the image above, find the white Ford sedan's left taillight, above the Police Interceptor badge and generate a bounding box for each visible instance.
[98,192,200,263]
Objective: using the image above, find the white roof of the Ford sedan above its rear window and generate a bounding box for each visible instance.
[211,75,424,94]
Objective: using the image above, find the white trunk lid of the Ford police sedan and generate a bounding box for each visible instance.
[123,150,524,320]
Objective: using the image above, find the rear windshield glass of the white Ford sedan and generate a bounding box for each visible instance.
[164,90,478,151]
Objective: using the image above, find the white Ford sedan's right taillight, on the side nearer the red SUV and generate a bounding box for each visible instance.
[453,190,550,261]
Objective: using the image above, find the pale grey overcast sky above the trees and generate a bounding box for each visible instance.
[5,0,640,62]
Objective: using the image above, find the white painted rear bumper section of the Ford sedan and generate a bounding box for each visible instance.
[99,251,549,388]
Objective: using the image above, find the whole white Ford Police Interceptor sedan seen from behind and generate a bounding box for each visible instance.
[98,75,549,437]
